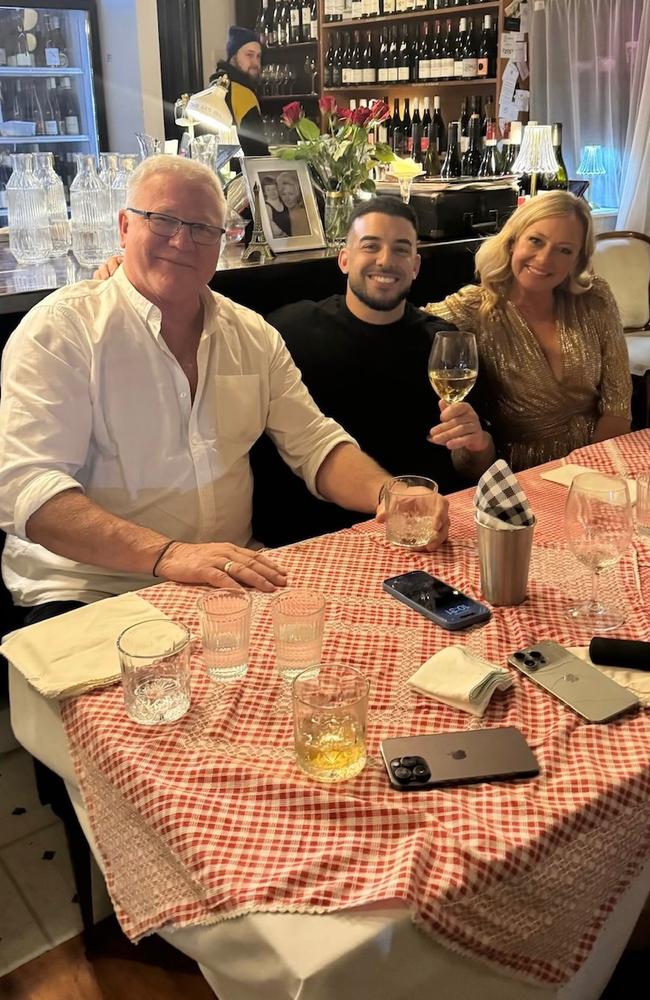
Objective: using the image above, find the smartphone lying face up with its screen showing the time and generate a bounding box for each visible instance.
[382,570,491,632]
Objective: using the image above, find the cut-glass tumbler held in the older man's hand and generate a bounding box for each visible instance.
[384,476,438,549]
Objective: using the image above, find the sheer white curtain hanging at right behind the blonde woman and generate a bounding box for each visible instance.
[528,0,650,232]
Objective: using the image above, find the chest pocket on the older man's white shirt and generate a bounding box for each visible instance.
[205,375,266,449]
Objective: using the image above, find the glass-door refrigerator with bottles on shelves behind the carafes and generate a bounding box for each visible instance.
[0,0,107,219]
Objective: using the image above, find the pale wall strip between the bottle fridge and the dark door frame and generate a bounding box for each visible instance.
[97,0,163,153]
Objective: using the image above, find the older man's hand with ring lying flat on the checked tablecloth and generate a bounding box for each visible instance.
[156,542,287,593]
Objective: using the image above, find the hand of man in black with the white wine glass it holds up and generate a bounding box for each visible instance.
[429,330,490,451]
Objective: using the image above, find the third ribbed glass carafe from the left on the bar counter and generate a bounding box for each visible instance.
[70,153,114,267]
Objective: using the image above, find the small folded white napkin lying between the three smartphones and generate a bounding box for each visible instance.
[407,646,513,718]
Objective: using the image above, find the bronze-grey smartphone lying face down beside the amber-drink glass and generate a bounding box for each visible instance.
[380,726,539,792]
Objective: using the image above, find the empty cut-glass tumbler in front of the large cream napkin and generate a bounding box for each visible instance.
[117,618,192,726]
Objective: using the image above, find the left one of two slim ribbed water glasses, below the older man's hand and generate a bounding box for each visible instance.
[197,589,251,681]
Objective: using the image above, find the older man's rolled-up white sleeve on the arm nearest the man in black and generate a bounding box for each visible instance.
[266,324,358,499]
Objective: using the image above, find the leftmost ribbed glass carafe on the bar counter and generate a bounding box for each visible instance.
[7,153,52,264]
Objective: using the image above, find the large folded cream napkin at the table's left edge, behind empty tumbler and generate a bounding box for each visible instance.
[0,594,167,698]
